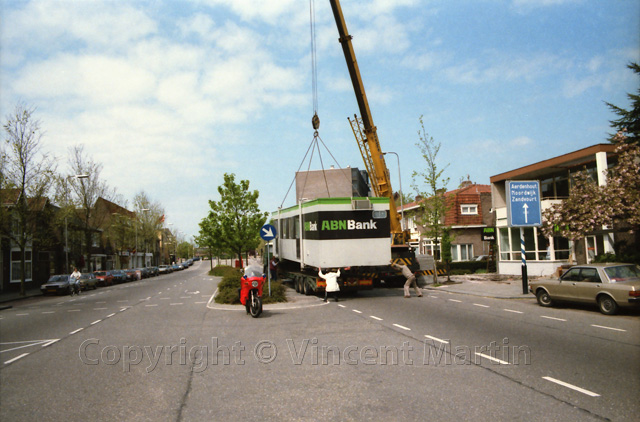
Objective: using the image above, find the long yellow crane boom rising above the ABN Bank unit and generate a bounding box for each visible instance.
[330,0,408,245]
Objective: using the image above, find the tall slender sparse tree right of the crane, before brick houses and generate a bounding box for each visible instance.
[412,116,449,283]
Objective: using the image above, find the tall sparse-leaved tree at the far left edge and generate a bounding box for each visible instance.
[0,104,55,295]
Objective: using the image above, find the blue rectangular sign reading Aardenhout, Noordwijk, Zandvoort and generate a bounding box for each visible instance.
[506,180,542,227]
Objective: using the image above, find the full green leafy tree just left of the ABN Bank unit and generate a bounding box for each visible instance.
[206,173,268,259]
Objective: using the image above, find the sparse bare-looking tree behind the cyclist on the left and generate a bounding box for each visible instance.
[64,145,117,271]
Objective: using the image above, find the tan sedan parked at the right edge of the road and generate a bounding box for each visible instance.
[529,264,640,315]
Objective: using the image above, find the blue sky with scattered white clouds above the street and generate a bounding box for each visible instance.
[0,0,640,240]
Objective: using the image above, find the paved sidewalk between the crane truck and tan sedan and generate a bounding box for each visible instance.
[423,274,535,299]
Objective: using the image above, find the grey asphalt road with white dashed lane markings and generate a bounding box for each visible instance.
[0,262,640,421]
